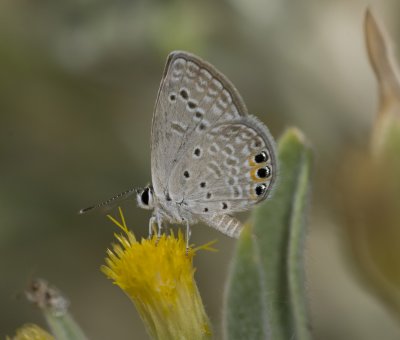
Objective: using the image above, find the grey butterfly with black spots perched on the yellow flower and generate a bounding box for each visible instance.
[80,51,277,240]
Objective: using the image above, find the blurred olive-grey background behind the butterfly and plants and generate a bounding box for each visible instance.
[0,0,400,340]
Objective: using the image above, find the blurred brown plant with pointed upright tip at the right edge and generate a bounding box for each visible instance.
[335,10,400,319]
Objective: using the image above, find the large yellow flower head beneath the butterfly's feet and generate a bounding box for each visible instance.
[101,209,214,340]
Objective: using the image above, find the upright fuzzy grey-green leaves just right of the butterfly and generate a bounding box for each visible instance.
[224,129,311,340]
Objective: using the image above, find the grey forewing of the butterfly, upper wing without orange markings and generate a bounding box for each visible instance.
[151,52,247,197]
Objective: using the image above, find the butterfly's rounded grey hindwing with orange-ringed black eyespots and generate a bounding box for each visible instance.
[170,116,277,217]
